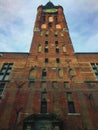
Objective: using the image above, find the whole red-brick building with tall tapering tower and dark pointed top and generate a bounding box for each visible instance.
[0,2,98,130]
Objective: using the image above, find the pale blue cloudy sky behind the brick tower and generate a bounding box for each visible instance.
[0,0,98,52]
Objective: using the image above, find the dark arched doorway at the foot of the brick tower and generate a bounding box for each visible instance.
[23,113,63,130]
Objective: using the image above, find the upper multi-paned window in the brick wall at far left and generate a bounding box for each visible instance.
[0,63,13,81]
